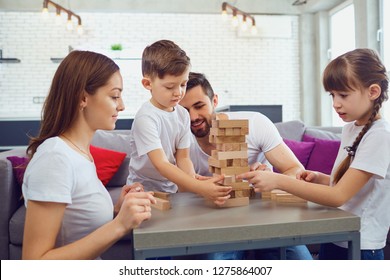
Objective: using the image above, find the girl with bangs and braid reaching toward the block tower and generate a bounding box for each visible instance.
[238,49,390,259]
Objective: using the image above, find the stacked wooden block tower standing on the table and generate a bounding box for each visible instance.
[208,114,251,207]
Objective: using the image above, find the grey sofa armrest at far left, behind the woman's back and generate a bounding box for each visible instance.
[0,148,26,260]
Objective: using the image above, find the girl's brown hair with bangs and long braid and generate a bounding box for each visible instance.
[323,49,389,184]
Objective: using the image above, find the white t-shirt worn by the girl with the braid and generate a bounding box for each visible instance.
[331,119,390,250]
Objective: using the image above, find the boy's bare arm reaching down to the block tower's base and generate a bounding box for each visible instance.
[148,149,232,204]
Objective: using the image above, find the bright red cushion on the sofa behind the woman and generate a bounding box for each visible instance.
[90,145,126,186]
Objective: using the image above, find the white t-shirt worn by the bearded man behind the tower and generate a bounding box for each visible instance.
[191,111,283,176]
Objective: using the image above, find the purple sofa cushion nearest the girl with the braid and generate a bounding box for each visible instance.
[302,135,340,175]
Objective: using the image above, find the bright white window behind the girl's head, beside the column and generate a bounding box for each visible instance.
[329,1,354,126]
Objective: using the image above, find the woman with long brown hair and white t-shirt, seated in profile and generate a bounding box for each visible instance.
[22,51,155,260]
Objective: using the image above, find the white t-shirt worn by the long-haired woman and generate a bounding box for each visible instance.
[22,137,114,247]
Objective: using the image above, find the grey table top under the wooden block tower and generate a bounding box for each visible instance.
[133,193,360,249]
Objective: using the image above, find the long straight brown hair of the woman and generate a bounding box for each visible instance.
[27,51,119,158]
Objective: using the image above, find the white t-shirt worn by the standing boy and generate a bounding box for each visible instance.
[127,101,191,193]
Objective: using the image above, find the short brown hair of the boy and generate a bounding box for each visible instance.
[142,40,191,79]
